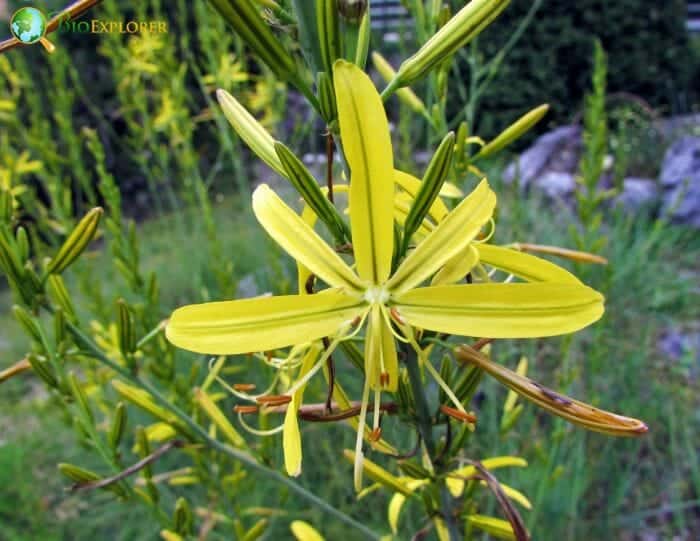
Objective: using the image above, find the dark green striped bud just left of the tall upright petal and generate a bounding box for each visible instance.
[275,141,350,243]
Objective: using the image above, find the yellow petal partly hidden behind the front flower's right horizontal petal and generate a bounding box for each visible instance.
[476,244,581,284]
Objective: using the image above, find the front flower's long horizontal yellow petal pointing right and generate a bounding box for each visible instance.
[394,283,604,338]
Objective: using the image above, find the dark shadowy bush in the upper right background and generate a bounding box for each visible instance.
[470,0,698,135]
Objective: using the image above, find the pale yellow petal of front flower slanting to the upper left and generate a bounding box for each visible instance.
[253,184,362,289]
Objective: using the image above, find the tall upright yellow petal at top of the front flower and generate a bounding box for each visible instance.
[333,60,394,284]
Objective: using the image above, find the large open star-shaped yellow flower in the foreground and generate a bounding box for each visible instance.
[166,61,603,486]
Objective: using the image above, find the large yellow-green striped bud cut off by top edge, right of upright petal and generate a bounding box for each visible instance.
[382,0,510,94]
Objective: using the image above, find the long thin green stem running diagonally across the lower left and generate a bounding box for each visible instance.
[67,323,380,540]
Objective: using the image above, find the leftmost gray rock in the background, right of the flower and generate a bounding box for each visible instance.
[503,126,581,190]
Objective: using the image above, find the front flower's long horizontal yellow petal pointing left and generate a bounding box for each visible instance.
[165,291,366,355]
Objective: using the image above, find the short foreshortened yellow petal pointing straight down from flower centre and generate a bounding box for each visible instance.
[365,306,399,393]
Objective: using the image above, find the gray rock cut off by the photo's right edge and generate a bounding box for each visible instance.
[660,136,700,228]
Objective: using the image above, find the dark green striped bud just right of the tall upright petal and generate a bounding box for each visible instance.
[403,132,455,253]
